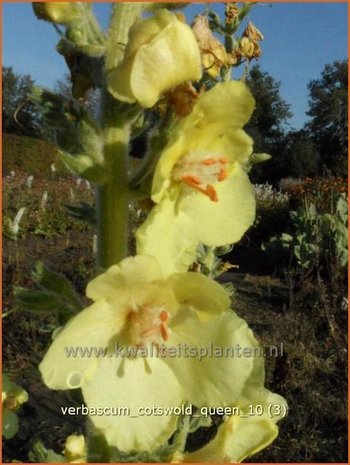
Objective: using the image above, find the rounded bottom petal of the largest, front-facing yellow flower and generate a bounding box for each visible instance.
[83,358,183,451]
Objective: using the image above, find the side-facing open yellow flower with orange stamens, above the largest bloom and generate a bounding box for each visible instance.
[136,81,255,274]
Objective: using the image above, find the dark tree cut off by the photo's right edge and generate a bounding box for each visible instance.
[306,60,348,176]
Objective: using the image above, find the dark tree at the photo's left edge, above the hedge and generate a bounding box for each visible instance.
[2,66,41,137]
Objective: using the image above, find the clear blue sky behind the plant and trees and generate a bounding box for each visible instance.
[3,2,348,129]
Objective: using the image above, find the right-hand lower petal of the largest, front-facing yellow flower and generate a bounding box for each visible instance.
[164,310,259,407]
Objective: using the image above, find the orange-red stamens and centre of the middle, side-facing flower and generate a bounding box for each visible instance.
[172,151,228,202]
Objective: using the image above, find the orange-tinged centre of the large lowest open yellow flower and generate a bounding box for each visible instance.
[126,305,170,347]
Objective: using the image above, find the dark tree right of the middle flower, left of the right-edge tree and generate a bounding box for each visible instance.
[245,65,292,182]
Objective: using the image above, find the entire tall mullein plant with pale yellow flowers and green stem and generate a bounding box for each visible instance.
[32,2,287,462]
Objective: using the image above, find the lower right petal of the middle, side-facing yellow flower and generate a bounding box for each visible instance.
[179,164,255,246]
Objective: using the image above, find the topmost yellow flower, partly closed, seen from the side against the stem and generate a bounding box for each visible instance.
[107,10,202,108]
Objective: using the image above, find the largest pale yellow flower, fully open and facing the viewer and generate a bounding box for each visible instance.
[39,256,263,451]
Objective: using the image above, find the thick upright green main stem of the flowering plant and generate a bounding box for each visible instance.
[96,3,141,268]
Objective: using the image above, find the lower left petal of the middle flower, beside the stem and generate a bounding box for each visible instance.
[136,198,198,276]
